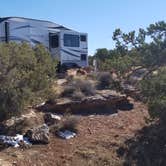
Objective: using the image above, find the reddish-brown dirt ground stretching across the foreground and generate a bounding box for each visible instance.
[0,99,148,166]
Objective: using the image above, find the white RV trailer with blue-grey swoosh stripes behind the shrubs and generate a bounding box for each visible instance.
[0,17,88,67]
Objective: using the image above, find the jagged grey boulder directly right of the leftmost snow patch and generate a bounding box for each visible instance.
[25,124,50,144]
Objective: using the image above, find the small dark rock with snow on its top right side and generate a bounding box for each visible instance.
[44,113,61,126]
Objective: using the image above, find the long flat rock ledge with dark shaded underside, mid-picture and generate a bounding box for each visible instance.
[38,90,128,113]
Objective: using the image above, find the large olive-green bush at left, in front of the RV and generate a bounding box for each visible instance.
[0,43,55,119]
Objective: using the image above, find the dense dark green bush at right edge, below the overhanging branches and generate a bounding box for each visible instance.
[141,68,166,121]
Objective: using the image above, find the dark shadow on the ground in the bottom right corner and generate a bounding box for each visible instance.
[117,120,166,166]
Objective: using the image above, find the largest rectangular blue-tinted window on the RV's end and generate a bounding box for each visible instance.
[64,34,80,47]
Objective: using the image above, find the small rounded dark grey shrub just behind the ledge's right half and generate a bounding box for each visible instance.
[97,72,112,89]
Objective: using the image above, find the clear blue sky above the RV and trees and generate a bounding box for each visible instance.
[0,0,166,55]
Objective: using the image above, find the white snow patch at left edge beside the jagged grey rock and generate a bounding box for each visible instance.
[0,134,31,148]
